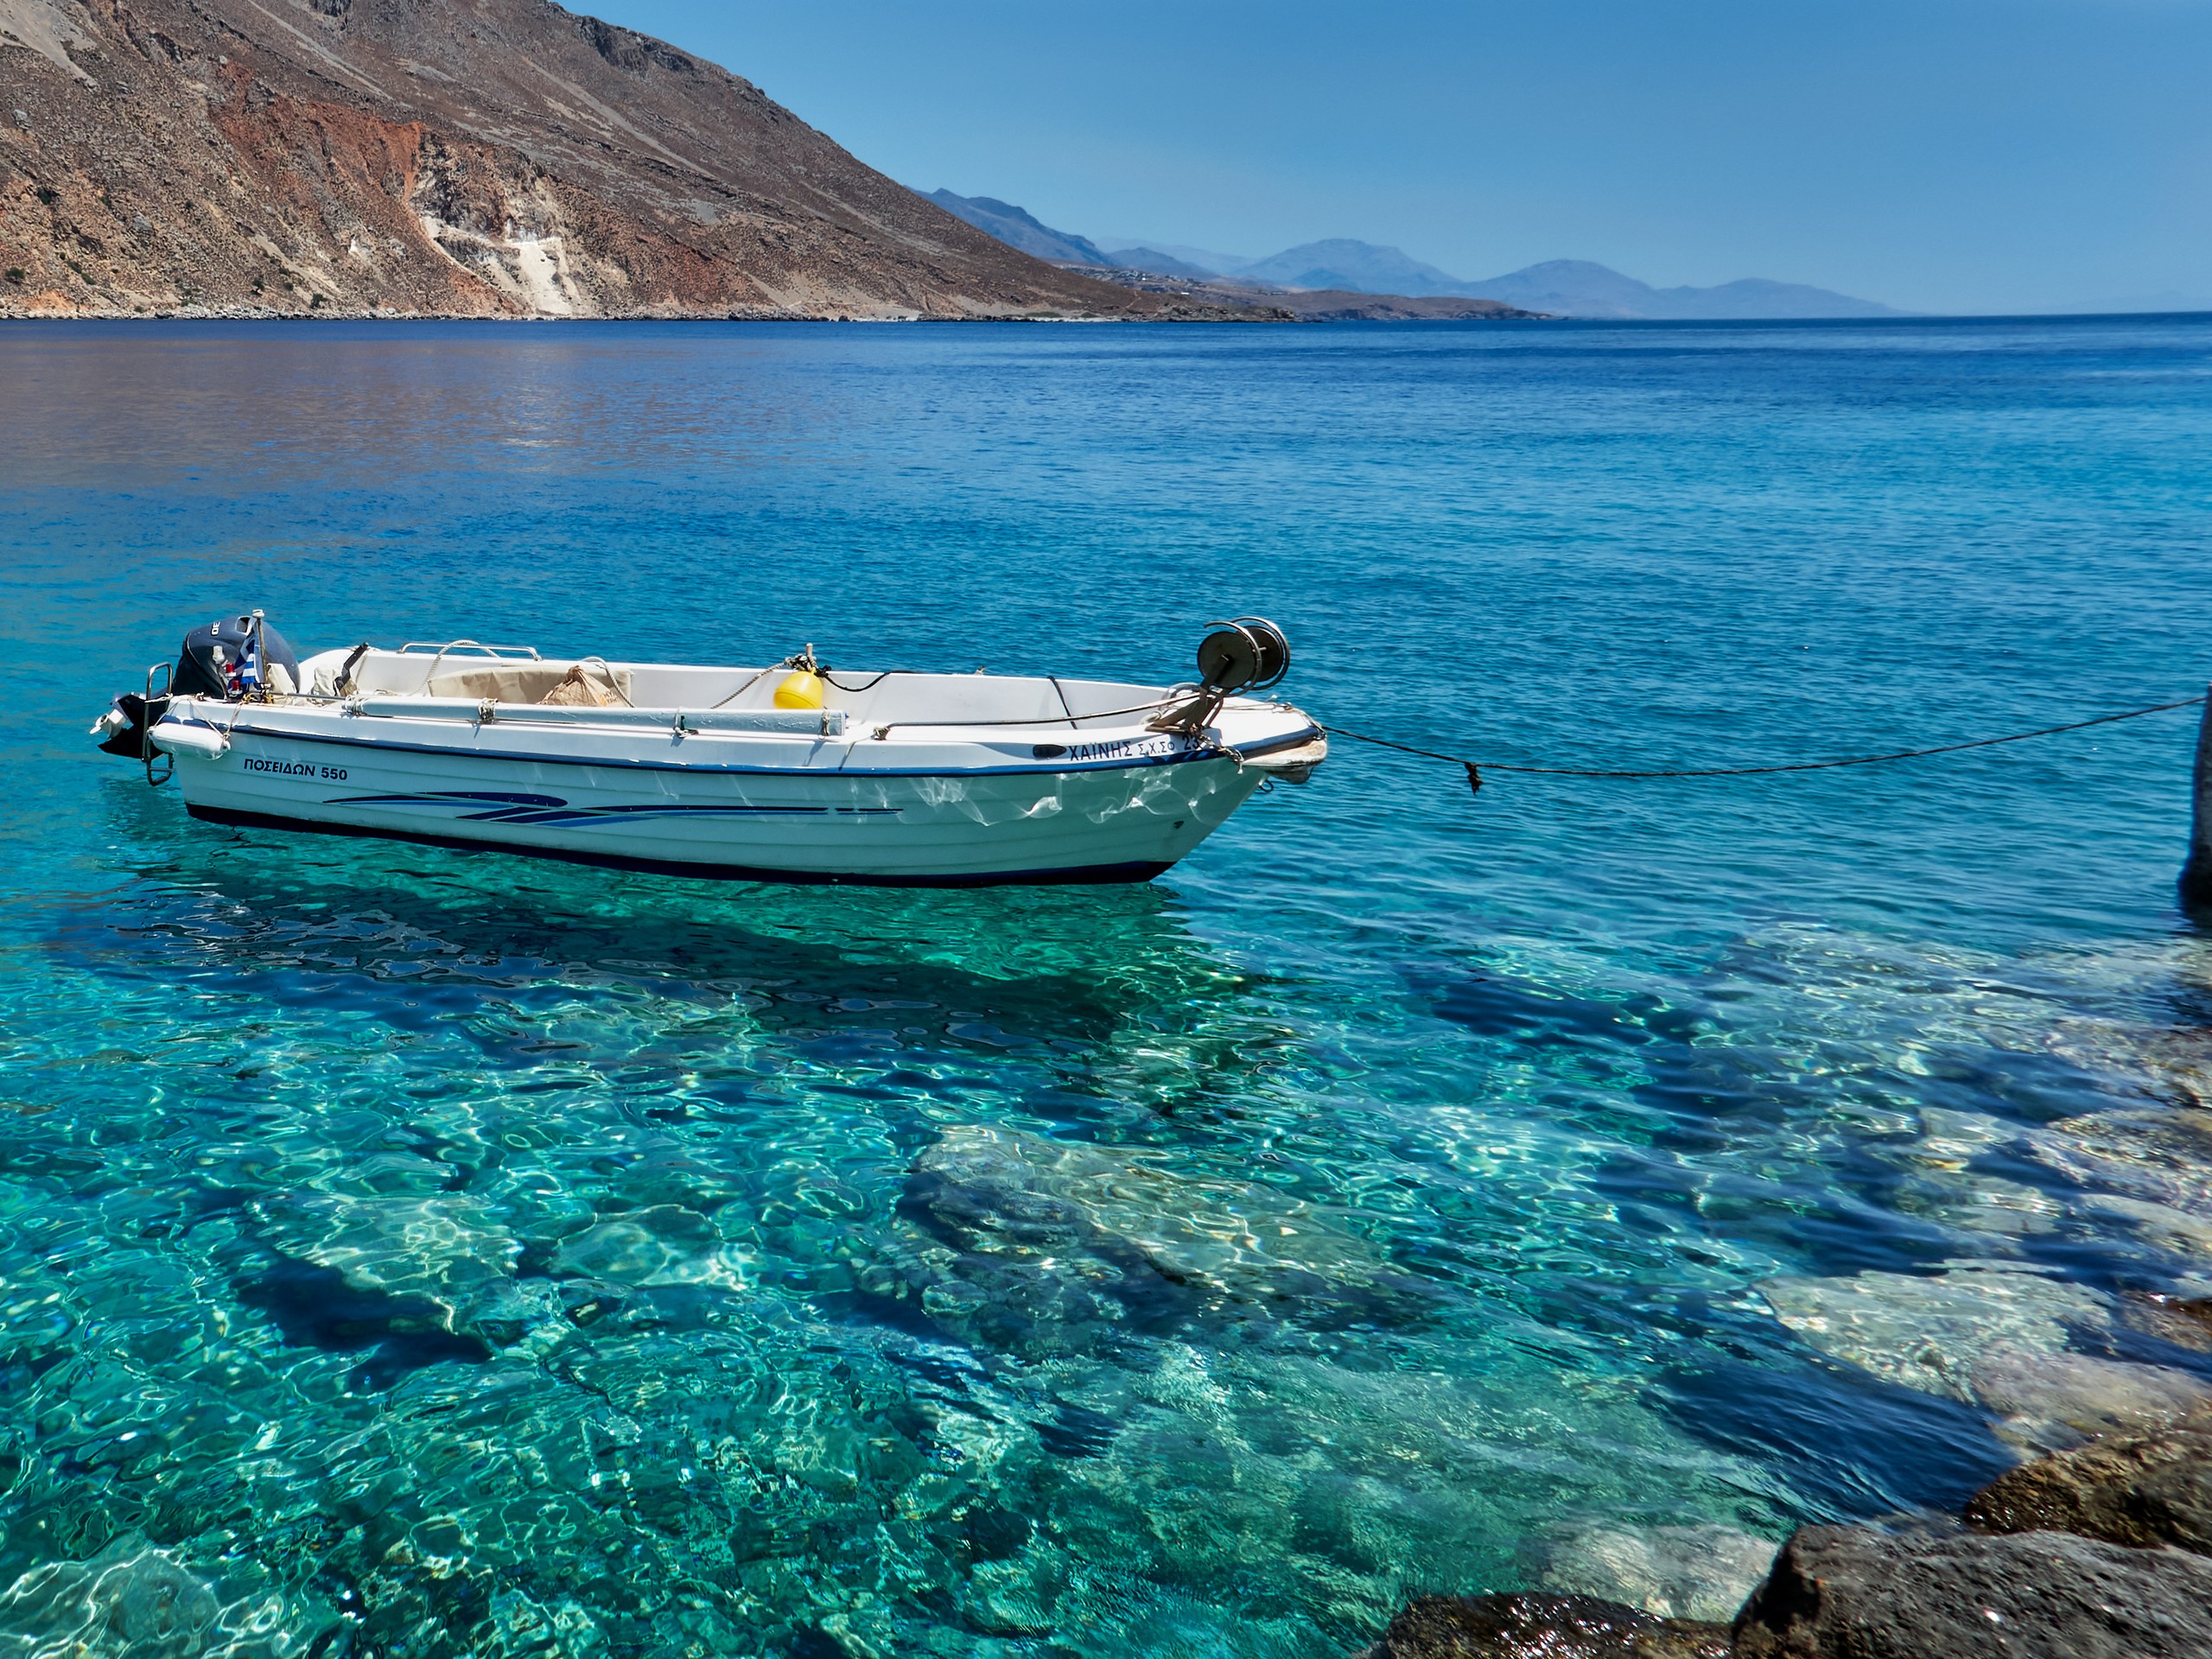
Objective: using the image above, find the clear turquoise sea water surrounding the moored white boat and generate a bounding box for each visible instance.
[0,319,2212,1656]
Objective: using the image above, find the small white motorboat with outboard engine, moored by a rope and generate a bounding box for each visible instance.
[93,613,1327,887]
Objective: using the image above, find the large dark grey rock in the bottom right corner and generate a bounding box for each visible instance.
[1734,1526,2212,1659]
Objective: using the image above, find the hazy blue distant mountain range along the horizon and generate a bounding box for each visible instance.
[929,190,1904,321]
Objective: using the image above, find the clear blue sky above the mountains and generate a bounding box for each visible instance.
[570,0,2212,312]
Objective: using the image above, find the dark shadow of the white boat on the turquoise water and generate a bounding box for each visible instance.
[69,779,1289,1117]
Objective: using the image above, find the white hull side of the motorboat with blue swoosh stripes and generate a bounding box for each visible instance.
[163,719,1265,887]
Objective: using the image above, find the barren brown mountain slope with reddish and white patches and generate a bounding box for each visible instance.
[0,0,1224,316]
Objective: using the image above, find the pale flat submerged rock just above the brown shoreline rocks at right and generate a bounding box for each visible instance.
[1758,1265,2110,1405]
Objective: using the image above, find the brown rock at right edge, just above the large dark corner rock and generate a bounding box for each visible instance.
[1967,1409,2212,1557]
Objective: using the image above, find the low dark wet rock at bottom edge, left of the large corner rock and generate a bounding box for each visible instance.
[1370,1595,1727,1659]
